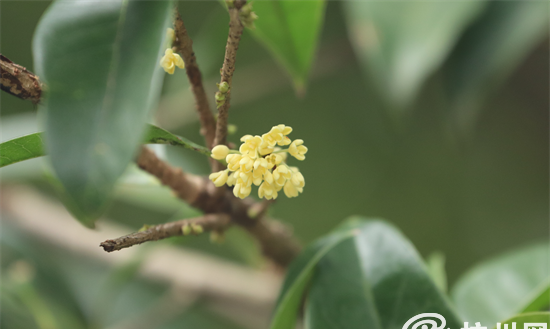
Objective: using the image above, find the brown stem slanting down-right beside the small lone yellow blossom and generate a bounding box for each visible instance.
[174,11,216,148]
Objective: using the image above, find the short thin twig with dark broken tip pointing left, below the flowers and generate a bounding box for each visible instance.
[100,214,231,252]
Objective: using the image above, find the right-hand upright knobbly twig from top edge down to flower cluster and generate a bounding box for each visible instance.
[214,0,246,151]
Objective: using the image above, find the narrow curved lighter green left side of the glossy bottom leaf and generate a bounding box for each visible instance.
[269,231,355,329]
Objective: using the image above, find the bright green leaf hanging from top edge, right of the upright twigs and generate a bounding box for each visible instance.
[247,0,326,94]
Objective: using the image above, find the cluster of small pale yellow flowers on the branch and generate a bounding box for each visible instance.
[209,124,307,200]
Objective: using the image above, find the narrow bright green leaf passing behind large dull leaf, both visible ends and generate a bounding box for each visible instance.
[0,125,210,168]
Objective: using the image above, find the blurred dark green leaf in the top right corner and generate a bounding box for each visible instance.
[447,0,550,123]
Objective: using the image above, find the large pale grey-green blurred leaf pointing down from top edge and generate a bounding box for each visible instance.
[344,0,485,107]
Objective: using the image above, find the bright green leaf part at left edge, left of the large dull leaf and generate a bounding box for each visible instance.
[0,133,44,168]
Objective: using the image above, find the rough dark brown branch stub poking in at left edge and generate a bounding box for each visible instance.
[0,54,42,104]
